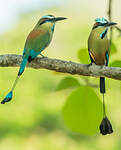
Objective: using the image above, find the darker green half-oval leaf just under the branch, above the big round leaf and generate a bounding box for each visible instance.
[56,77,80,91]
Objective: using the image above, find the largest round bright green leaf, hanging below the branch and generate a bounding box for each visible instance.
[63,87,103,135]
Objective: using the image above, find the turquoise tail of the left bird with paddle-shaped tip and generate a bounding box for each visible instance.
[1,58,27,104]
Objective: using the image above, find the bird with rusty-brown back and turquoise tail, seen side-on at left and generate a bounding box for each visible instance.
[1,15,67,104]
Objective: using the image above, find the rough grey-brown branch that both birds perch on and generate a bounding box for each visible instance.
[0,54,121,80]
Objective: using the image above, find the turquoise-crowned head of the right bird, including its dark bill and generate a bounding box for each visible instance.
[93,18,117,29]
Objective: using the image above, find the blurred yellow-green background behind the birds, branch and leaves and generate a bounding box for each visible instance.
[0,0,121,150]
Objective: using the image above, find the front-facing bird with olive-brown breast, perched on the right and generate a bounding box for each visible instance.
[88,18,117,135]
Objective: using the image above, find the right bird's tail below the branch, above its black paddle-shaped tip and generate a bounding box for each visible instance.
[100,77,106,117]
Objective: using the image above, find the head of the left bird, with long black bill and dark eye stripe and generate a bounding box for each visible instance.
[35,15,67,31]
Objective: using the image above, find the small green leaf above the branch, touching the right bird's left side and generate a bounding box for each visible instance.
[78,48,91,64]
